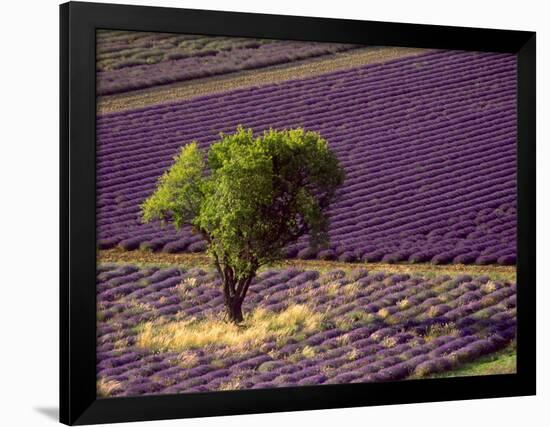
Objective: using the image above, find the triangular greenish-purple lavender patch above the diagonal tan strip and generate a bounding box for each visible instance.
[97,31,357,95]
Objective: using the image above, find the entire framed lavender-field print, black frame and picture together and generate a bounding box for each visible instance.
[60,2,535,424]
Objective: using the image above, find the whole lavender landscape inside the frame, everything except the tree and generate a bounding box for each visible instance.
[96,31,517,397]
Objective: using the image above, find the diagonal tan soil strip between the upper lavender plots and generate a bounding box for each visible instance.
[97,47,428,114]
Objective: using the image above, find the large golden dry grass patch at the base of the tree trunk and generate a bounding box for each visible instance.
[137,305,323,351]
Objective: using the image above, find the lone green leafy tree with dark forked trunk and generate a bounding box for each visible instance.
[141,126,344,323]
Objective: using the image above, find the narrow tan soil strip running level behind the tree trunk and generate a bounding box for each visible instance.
[97,249,516,283]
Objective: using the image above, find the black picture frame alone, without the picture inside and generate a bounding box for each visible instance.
[60,2,536,425]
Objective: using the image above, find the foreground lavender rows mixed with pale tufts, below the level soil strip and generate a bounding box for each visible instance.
[97,265,516,396]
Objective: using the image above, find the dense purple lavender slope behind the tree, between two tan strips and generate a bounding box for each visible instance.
[97,52,516,264]
